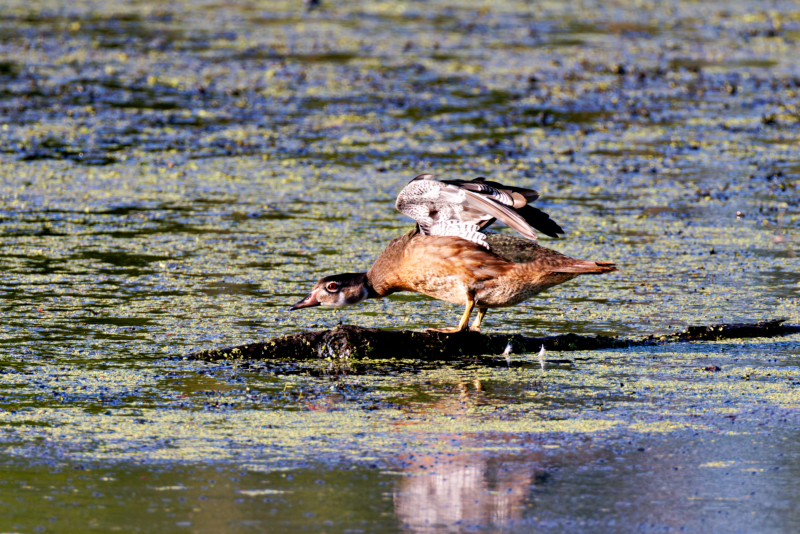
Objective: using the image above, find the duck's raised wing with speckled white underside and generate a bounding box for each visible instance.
[395,174,544,246]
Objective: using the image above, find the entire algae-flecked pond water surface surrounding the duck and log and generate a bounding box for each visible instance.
[0,0,800,533]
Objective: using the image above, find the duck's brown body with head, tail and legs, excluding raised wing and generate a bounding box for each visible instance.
[289,228,616,332]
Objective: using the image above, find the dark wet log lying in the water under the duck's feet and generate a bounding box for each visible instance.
[188,319,800,361]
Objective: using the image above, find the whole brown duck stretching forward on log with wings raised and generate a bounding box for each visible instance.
[289,174,616,334]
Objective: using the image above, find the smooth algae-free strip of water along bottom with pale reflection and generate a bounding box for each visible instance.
[0,436,800,532]
